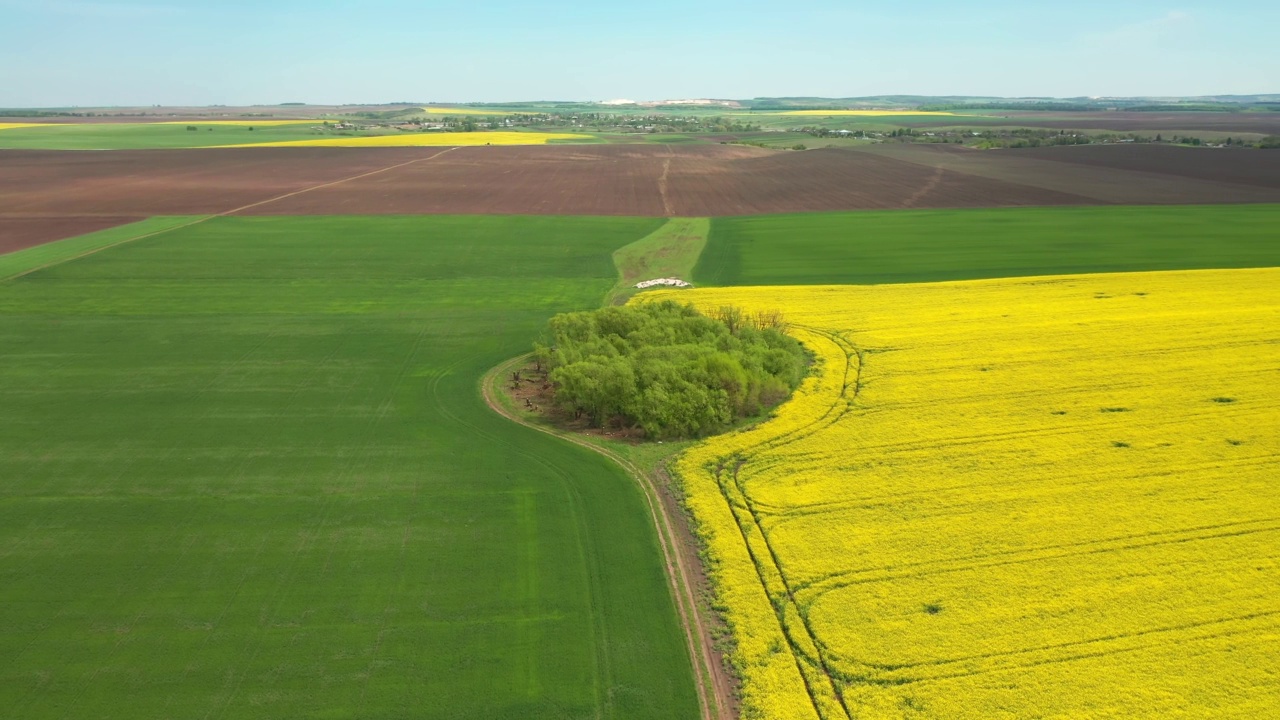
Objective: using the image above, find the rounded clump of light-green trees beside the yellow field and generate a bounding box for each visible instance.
[534,301,809,438]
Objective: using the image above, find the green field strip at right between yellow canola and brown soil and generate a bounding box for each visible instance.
[694,205,1280,286]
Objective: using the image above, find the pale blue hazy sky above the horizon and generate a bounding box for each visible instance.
[0,0,1280,108]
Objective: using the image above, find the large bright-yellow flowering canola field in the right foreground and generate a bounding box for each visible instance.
[643,269,1280,720]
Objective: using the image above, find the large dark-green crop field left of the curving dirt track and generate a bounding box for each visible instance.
[0,217,698,720]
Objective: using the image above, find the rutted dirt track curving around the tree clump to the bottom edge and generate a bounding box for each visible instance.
[480,355,735,720]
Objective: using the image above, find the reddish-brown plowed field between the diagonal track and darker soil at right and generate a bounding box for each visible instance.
[241,145,1089,217]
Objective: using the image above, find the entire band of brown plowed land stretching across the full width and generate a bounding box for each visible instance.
[0,143,1280,251]
